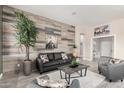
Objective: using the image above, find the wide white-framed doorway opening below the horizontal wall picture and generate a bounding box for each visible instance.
[93,36,114,61]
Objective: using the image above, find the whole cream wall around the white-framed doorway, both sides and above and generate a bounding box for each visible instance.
[75,18,124,60]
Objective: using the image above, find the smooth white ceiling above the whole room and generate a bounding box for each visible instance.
[12,5,124,26]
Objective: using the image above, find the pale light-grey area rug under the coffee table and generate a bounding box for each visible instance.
[47,70,105,88]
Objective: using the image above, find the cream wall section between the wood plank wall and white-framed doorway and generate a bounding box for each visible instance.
[75,26,92,60]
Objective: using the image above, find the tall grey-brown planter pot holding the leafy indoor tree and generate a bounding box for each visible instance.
[23,61,32,76]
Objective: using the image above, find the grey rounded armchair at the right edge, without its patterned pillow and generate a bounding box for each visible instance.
[98,56,124,82]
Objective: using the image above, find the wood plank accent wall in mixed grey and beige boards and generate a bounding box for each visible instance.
[2,6,75,72]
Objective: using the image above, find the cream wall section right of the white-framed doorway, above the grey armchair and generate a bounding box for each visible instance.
[110,19,124,59]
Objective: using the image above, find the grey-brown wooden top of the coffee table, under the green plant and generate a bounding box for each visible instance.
[58,64,89,74]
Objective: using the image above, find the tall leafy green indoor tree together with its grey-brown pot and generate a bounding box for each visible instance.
[15,12,37,75]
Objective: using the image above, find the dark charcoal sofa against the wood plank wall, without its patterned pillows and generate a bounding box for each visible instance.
[36,52,73,74]
